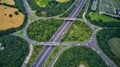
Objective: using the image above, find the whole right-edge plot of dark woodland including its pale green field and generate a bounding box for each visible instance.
[96,28,120,67]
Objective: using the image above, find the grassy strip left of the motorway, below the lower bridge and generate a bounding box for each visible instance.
[27,45,43,67]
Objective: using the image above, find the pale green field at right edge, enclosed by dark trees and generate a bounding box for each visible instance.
[109,38,120,59]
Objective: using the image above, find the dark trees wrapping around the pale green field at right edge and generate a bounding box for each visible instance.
[96,28,120,67]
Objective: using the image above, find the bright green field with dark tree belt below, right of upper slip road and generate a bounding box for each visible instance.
[87,12,120,27]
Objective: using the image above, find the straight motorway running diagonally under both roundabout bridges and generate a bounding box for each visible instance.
[32,0,85,67]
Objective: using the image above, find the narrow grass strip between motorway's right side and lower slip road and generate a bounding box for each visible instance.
[44,46,65,67]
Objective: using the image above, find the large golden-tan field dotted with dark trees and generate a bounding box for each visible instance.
[0,5,24,30]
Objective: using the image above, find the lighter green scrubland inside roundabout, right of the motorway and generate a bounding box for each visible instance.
[61,21,92,42]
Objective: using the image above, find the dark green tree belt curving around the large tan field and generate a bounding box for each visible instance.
[0,0,27,37]
